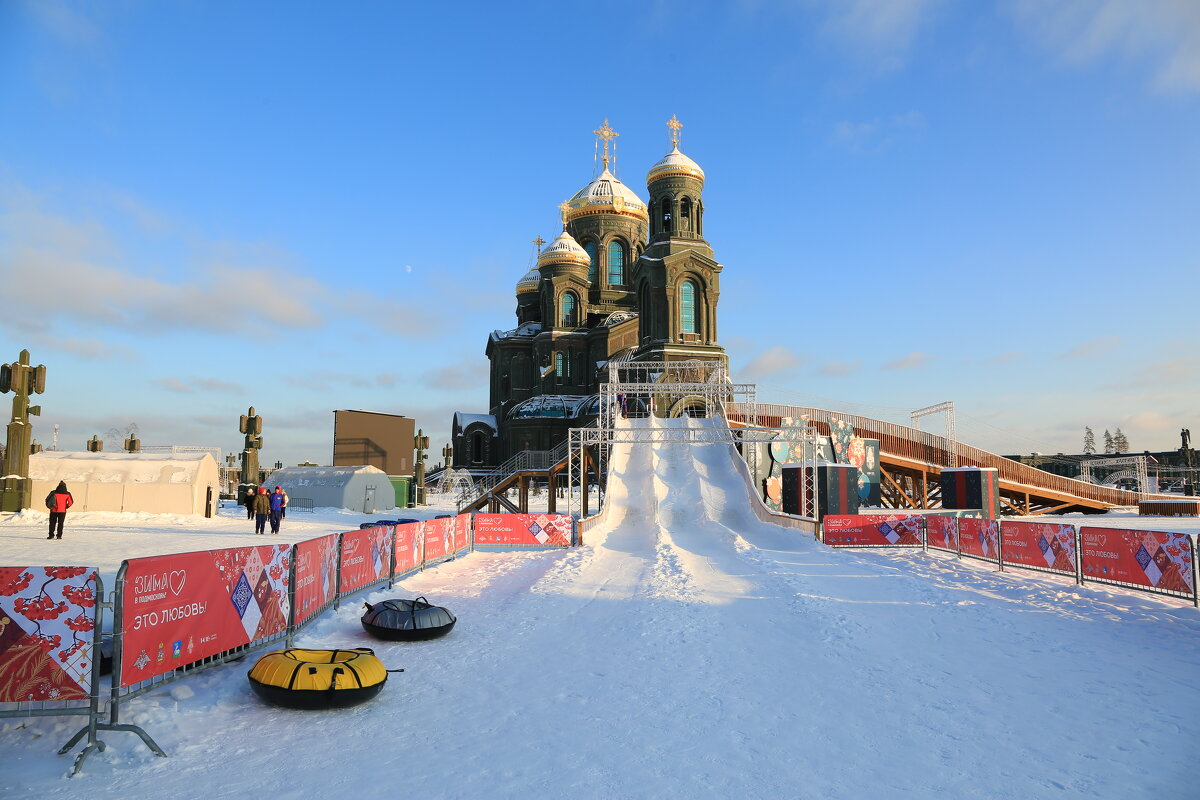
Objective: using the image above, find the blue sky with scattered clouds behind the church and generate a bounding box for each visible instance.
[0,0,1200,463]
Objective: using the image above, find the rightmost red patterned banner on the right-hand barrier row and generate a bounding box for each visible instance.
[1079,528,1195,597]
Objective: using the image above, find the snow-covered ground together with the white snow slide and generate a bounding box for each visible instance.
[0,421,1200,800]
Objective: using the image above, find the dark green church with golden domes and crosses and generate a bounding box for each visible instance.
[451,116,726,469]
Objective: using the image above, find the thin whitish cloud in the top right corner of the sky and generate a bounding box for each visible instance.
[1009,0,1200,92]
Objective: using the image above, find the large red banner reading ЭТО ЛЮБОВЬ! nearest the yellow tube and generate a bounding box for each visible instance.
[120,545,292,686]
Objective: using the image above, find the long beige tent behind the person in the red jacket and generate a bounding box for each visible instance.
[29,451,220,515]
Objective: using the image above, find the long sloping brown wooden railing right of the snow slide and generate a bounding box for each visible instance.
[726,403,1158,506]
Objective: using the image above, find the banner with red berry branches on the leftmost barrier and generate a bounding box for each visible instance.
[0,566,96,703]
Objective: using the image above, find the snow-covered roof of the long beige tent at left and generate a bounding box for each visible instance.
[29,450,216,489]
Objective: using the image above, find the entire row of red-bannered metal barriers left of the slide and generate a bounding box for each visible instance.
[0,515,575,775]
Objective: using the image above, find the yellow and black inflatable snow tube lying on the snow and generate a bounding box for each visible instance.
[247,648,388,709]
